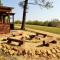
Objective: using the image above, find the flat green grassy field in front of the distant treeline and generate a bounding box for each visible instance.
[15,25,60,34]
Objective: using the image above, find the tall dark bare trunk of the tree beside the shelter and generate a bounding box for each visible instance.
[21,0,28,30]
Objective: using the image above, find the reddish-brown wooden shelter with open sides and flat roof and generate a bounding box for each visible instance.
[0,6,14,34]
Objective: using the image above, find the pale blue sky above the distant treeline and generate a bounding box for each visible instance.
[2,0,60,21]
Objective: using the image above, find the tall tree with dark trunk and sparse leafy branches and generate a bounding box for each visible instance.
[19,0,53,30]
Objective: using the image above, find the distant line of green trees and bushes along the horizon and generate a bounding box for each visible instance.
[15,19,60,27]
